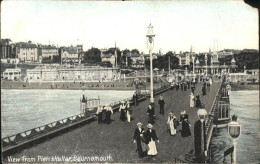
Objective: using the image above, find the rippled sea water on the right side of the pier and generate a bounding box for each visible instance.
[211,91,260,163]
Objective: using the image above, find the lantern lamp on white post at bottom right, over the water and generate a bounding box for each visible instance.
[228,115,241,163]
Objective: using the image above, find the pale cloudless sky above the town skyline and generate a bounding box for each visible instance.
[1,0,258,53]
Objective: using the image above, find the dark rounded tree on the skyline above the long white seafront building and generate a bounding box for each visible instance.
[83,47,101,63]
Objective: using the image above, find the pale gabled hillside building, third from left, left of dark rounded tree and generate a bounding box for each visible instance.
[60,46,80,65]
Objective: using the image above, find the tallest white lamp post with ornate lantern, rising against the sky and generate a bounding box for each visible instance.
[146,24,155,104]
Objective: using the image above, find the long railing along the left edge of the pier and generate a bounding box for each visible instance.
[1,85,169,154]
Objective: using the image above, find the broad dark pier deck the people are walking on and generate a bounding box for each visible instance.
[4,83,220,163]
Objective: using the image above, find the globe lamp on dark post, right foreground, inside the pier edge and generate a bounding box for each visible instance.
[197,108,207,160]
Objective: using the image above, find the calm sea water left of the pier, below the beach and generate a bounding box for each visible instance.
[1,89,134,137]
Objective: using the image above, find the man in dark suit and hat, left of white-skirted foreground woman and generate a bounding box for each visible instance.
[134,122,148,158]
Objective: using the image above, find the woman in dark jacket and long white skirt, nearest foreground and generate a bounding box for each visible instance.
[146,124,159,160]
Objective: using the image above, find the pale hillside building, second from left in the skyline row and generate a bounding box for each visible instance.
[38,45,59,63]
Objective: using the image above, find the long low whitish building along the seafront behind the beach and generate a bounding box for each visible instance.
[27,66,120,82]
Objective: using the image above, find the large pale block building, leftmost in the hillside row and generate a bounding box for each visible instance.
[15,41,39,63]
